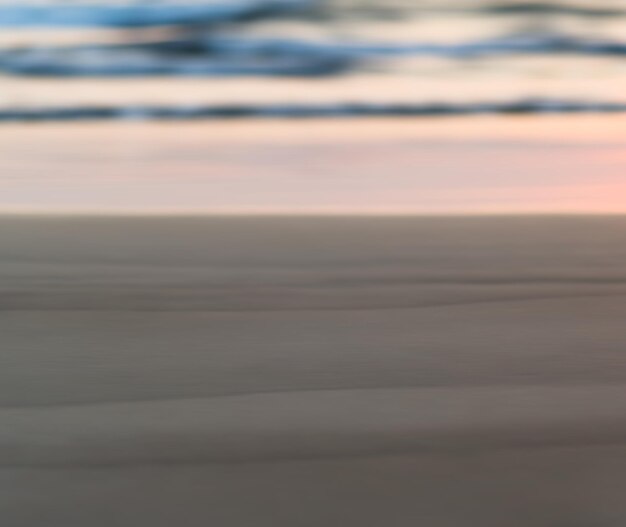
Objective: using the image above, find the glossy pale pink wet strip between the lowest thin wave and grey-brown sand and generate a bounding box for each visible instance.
[0,115,626,215]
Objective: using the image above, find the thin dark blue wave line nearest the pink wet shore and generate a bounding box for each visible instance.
[0,99,626,122]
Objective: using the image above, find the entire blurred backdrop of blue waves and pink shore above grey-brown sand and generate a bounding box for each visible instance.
[0,0,626,214]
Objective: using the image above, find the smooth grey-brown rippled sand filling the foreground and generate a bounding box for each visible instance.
[0,216,626,527]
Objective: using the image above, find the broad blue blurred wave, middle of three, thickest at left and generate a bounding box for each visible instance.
[0,33,626,77]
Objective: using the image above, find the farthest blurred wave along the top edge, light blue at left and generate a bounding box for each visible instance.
[0,0,626,28]
